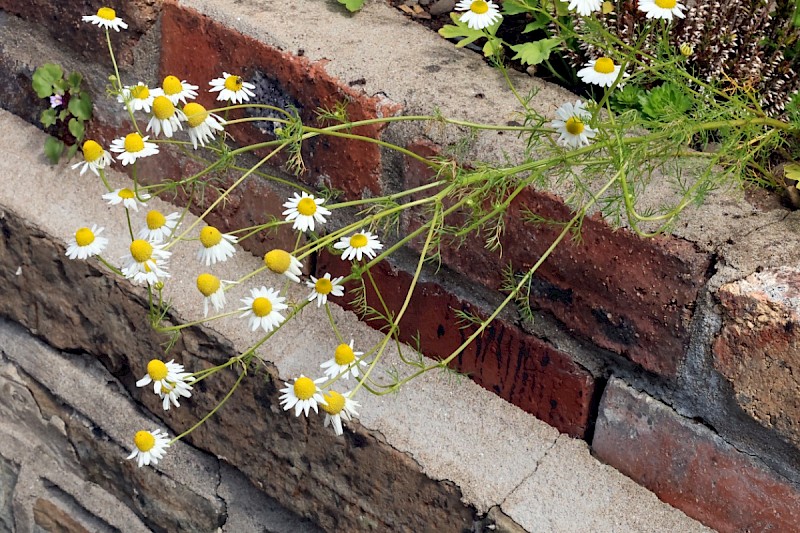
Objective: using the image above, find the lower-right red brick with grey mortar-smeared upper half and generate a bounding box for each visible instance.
[592,379,800,533]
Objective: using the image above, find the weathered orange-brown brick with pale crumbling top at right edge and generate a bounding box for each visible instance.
[713,267,800,448]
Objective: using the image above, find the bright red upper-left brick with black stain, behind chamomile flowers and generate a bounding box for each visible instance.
[160,3,400,199]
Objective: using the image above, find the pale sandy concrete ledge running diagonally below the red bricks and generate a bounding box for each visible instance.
[0,108,703,531]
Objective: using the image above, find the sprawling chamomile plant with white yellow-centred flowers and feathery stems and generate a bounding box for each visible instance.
[66,0,797,466]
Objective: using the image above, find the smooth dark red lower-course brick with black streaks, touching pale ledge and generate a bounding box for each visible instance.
[317,249,594,438]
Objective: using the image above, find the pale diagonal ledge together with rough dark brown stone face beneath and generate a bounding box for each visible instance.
[0,107,706,532]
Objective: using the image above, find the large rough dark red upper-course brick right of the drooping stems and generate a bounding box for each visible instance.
[404,142,710,376]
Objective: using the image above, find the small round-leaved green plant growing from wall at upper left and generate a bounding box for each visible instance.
[31,63,92,164]
